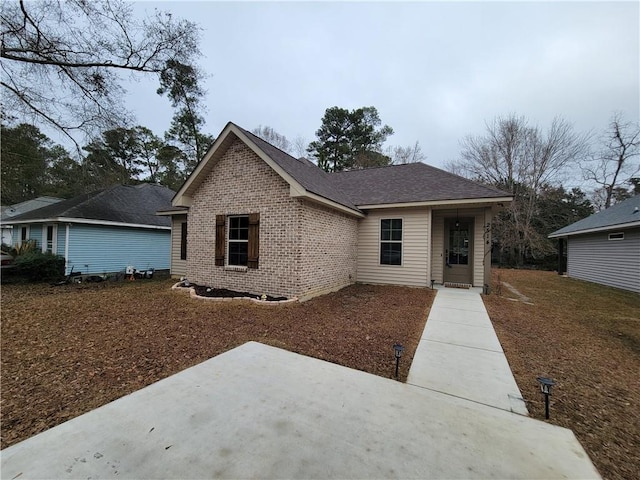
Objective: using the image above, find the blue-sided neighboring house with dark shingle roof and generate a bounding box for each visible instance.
[2,184,175,274]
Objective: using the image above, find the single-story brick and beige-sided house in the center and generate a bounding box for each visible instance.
[159,123,512,299]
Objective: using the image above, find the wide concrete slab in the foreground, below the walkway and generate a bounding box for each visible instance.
[1,342,600,479]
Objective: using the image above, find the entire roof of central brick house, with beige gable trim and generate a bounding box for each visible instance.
[172,122,512,216]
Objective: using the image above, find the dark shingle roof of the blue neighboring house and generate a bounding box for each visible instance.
[5,183,175,227]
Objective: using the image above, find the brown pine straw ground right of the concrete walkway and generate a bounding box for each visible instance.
[484,270,640,479]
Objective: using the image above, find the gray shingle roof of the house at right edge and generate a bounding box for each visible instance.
[549,195,640,238]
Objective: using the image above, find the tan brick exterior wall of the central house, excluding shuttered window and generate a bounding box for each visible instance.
[187,140,357,298]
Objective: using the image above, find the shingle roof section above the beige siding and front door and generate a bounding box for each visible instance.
[331,163,511,206]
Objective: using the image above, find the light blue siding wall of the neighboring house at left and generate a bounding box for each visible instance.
[66,224,171,274]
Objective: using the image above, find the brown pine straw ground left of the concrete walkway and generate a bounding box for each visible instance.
[0,279,433,448]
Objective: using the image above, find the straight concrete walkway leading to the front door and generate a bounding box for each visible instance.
[407,288,535,415]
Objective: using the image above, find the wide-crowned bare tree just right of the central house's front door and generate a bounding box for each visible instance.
[447,115,589,264]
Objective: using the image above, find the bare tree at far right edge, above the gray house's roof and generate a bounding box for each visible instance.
[582,113,640,208]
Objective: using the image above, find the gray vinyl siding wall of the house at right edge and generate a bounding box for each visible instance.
[567,228,640,292]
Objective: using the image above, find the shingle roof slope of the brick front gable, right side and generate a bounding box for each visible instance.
[236,125,357,210]
